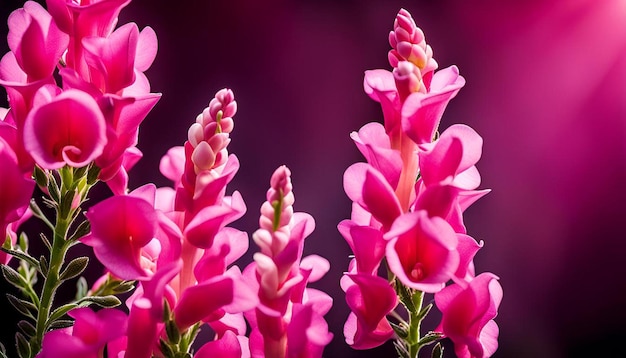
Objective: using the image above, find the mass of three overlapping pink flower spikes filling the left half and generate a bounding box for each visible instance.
[0,0,332,358]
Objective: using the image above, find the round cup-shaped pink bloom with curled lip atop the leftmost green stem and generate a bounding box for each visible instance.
[24,90,106,169]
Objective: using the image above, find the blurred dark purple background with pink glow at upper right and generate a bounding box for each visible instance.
[0,0,626,358]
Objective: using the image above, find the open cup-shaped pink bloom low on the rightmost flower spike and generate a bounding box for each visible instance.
[385,211,460,293]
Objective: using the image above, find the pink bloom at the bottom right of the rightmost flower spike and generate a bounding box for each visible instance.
[435,273,502,358]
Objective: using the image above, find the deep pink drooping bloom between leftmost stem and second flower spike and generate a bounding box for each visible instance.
[82,196,158,280]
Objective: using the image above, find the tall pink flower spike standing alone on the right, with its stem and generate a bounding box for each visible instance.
[339,10,502,357]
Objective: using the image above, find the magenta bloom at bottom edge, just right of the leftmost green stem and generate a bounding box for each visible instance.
[37,308,127,358]
